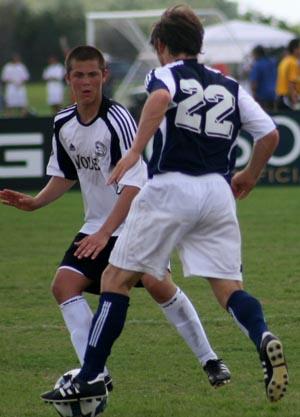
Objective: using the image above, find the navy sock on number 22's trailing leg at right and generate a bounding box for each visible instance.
[227,290,268,351]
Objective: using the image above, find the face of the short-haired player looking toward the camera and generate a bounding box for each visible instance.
[67,59,107,105]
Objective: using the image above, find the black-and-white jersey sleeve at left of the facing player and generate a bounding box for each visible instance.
[46,128,78,181]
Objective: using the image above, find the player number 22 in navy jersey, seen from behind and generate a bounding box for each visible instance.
[38,6,288,402]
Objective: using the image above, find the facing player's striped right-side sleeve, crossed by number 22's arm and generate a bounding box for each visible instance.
[107,105,147,188]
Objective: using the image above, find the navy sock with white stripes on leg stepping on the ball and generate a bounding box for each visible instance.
[78,292,129,381]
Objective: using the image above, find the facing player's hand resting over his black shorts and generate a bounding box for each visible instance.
[74,231,110,259]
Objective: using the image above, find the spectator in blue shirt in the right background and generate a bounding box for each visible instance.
[249,45,277,111]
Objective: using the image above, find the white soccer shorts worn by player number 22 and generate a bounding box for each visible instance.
[109,173,242,281]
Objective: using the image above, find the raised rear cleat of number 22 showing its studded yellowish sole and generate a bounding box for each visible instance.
[259,334,289,402]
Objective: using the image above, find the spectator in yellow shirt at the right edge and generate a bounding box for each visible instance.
[276,38,300,110]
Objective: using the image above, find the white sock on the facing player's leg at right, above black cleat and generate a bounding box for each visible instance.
[160,288,217,366]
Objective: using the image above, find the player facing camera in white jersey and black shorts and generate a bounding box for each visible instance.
[0,46,230,394]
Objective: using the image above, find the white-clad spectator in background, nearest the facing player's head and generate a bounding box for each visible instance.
[43,55,65,114]
